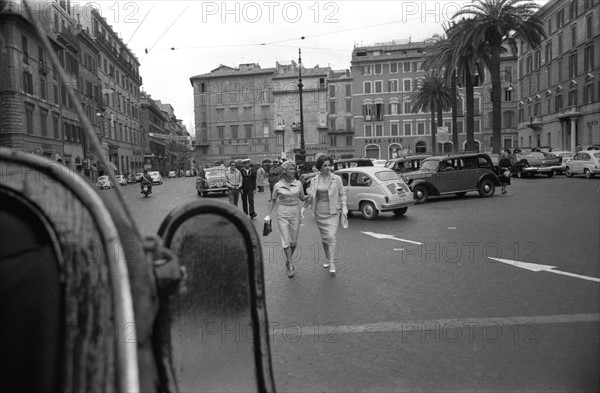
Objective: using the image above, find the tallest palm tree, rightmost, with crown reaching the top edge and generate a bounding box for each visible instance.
[453,0,546,154]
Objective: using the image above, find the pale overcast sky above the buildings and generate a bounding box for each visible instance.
[85,0,546,135]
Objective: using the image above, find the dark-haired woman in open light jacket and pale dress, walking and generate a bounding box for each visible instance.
[300,155,348,276]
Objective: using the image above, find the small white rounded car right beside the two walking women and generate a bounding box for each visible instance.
[335,166,415,220]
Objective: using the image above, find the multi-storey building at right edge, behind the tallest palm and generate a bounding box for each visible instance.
[517,0,600,151]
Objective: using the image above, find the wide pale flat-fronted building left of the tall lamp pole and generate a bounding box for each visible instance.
[190,63,281,166]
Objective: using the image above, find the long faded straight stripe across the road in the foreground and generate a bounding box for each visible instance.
[269,314,600,336]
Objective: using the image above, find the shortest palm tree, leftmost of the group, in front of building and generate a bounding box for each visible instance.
[411,71,451,154]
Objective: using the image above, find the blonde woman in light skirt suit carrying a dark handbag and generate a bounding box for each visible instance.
[265,161,308,278]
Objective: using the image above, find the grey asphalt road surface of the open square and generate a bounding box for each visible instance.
[100,176,600,392]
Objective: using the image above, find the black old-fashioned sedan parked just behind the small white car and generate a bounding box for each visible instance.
[404,153,500,203]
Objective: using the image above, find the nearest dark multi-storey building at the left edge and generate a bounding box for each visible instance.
[0,2,85,171]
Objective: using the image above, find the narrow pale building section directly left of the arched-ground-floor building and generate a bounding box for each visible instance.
[323,70,355,158]
